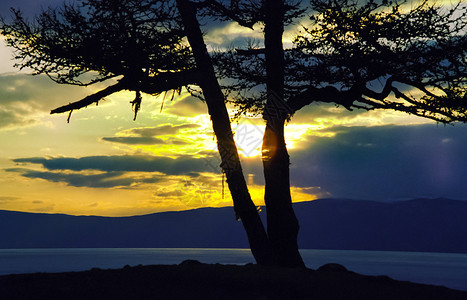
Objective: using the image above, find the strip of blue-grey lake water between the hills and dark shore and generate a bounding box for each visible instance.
[0,248,467,290]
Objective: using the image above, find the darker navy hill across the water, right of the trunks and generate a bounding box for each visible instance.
[295,199,467,253]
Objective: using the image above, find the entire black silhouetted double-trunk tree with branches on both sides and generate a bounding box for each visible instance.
[2,0,467,267]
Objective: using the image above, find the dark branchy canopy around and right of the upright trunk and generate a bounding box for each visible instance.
[216,0,467,123]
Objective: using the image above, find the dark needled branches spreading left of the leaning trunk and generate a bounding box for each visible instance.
[0,0,195,119]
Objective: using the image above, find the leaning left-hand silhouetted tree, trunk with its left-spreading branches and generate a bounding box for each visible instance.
[1,0,273,265]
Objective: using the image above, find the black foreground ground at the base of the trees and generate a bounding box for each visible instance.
[0,261,467,300]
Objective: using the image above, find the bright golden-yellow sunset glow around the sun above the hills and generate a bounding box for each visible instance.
[0,82,438,216]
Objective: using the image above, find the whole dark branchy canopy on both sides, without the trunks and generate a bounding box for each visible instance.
[2,0,467,123]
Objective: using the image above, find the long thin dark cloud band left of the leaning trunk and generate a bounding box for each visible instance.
[5,156,210,188]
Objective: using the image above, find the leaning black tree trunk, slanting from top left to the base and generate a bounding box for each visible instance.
[177,0,274,265]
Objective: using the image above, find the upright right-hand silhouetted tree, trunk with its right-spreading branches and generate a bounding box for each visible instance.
[215,0,467,266]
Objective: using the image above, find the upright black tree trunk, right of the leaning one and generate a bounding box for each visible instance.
[262,0,305,267]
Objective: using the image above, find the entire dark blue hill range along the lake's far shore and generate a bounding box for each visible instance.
[0,199,467,253]
